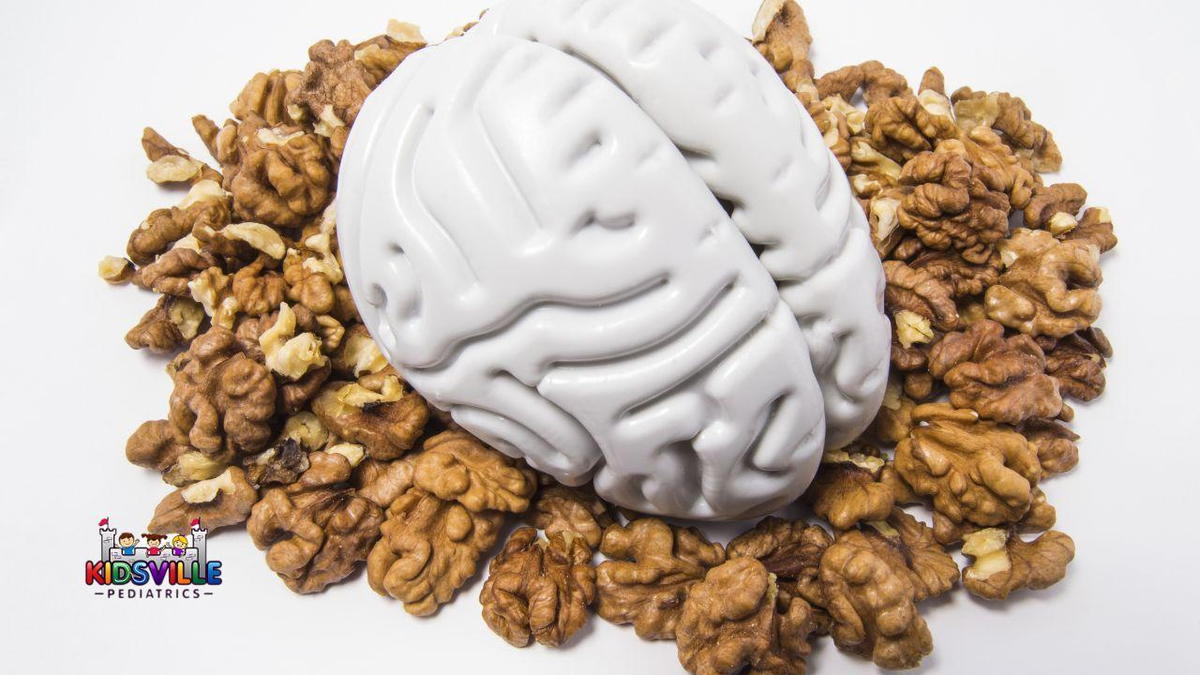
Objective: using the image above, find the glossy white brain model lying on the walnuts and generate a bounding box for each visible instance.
[338,0,889,519]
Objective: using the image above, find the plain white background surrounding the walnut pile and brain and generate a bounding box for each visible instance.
[0,0,1200,674]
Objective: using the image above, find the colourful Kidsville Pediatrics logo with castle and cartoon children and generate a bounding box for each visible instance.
[83,518,221,599]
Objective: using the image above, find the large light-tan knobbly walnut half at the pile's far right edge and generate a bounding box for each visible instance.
[984,228,1102,338]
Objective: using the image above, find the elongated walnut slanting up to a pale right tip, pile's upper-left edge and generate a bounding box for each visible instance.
[125,180,230,265]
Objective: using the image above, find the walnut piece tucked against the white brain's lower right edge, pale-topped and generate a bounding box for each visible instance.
[804,448,894,530]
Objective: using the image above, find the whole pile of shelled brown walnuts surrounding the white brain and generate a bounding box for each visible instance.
[100,0,1116,673]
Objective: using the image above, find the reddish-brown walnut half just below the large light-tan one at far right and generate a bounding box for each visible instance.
[929,321,1062,424]
